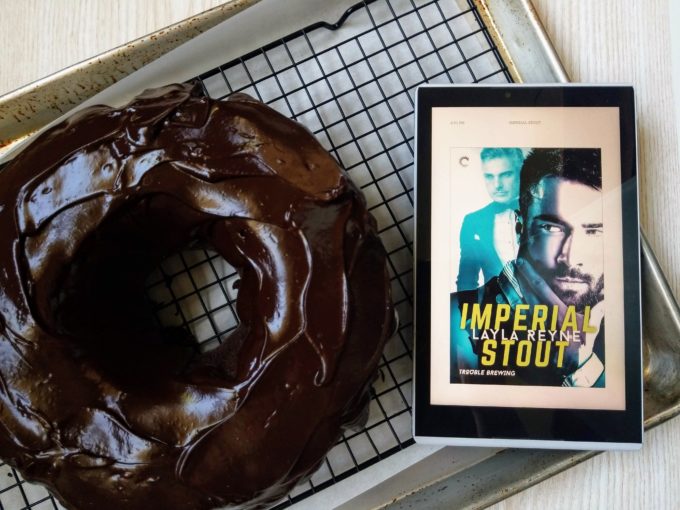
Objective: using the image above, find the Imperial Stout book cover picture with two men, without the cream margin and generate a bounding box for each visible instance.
[450,147,606,387]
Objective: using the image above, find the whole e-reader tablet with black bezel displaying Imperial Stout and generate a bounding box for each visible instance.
[414,85,642,449]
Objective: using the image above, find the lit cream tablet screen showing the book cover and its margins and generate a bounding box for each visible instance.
[431,108,625,410]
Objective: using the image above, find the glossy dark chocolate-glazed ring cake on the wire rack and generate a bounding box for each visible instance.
[0,85,394,510]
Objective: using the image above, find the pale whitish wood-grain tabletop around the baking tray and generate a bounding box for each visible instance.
[0,0,680,510]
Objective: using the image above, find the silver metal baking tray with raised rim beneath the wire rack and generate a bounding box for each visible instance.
[0,0,680,510]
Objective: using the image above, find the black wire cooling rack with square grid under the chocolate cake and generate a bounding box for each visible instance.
[0,0,511,510]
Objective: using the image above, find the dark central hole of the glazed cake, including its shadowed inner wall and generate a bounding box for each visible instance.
[50,195,239,378]
